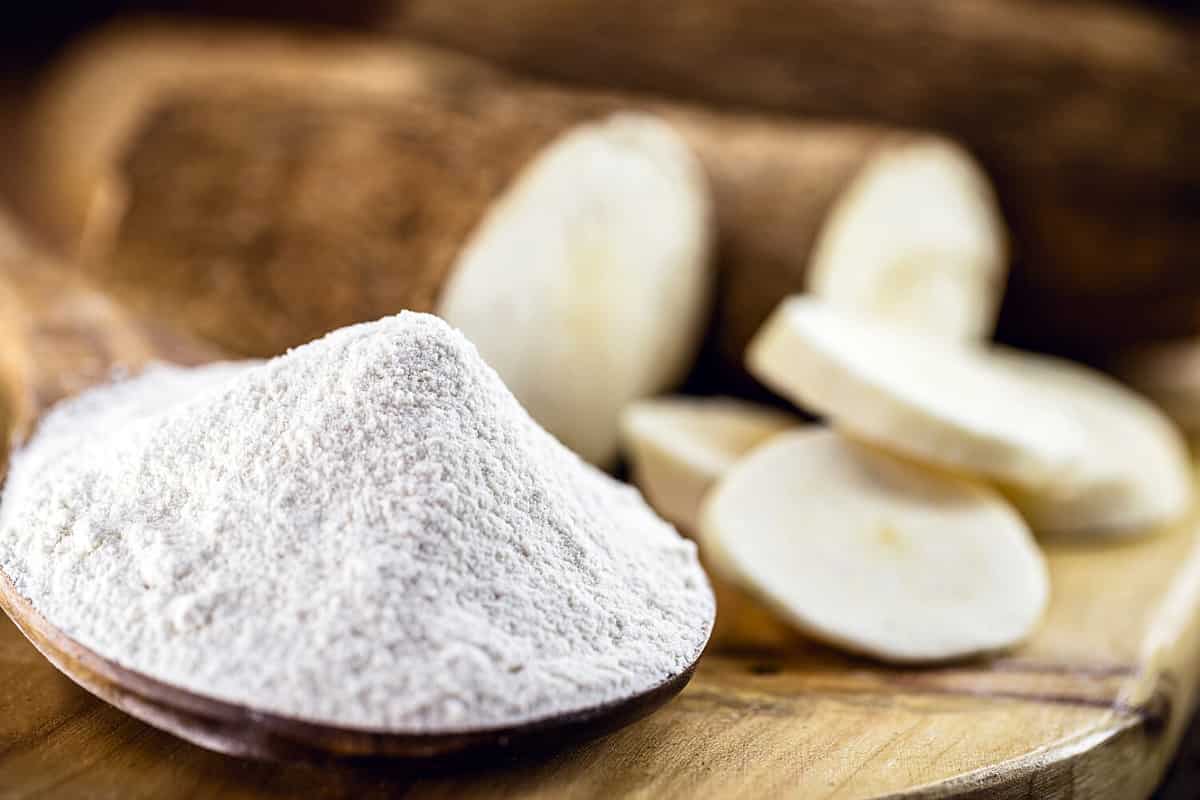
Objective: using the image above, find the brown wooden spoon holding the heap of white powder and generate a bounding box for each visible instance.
[0,225,695,762]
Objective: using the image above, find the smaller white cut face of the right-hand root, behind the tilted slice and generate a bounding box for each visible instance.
[808,138,1008,339]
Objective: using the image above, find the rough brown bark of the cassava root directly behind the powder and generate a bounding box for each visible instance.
[84,86,566,355]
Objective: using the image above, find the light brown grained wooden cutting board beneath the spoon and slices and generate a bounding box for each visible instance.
[0,253,1200,800]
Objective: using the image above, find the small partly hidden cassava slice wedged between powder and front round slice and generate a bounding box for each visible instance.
[622,397,798,533]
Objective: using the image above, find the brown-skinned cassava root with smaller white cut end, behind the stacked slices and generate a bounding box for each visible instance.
[667,114,1008,369]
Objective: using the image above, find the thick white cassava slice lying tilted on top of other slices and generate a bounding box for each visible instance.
[746,296,1086,491]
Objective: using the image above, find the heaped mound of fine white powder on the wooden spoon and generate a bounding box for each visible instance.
[0,313,714,733]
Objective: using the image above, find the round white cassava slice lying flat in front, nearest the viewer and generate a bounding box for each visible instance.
[701,429,1049,662]
